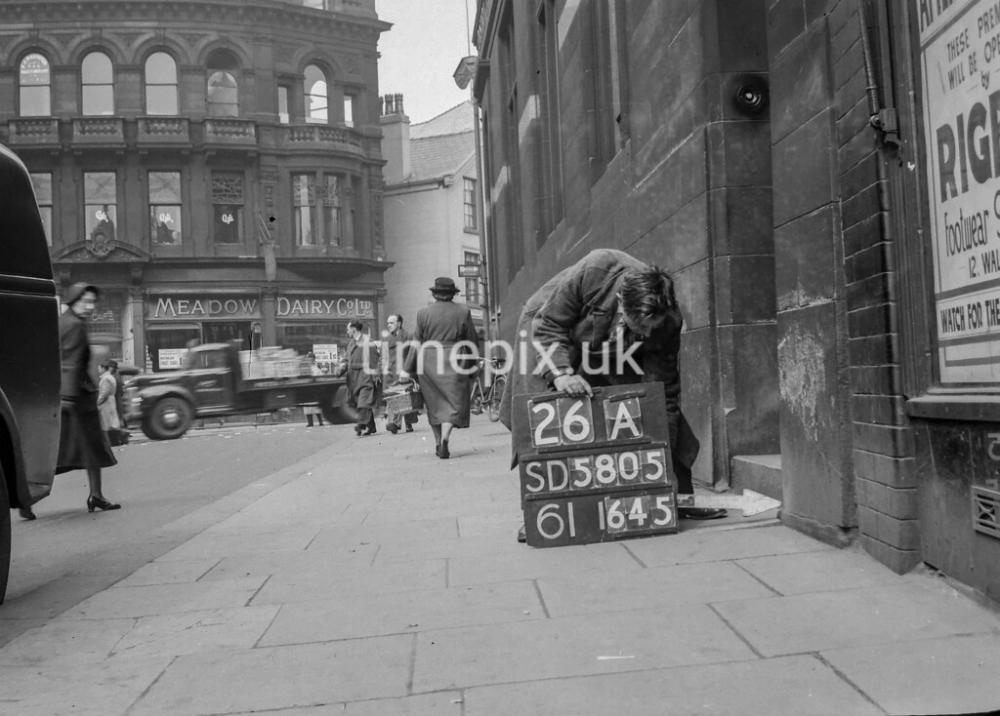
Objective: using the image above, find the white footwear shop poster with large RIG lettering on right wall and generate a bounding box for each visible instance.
[915,0,1000,384]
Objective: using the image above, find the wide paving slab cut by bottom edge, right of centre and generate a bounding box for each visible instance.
[464,656,882,716]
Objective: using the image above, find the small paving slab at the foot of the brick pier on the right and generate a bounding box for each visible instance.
[737,549,916,594]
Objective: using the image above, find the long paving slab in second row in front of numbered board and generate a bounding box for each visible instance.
[538,562,774,617]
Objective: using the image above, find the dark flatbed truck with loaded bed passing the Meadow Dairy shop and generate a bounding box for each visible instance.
[125,343,357,440]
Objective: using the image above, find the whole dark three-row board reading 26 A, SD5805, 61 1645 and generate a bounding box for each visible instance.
[512,383,677,547]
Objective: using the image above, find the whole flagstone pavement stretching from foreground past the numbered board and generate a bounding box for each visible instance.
[0,416,1000,716]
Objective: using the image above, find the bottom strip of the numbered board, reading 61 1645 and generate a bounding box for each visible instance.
[524,486,677,547]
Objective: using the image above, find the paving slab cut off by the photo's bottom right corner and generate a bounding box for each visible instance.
[822,633,1000,716]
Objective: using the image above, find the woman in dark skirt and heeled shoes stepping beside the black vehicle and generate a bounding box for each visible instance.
[21,283,121,519]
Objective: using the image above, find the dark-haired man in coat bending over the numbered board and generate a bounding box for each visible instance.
[500,249,726,539]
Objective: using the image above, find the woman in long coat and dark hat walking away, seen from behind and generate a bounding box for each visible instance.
[400,277,478,460]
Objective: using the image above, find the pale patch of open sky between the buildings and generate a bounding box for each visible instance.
[375,0,476,124]
